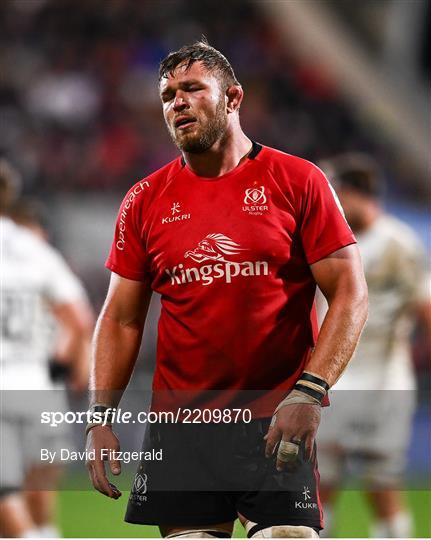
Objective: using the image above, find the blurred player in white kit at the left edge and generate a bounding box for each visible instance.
[0,160,93,537]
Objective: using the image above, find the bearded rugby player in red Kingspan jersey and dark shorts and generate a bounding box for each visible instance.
[87,42,367,538]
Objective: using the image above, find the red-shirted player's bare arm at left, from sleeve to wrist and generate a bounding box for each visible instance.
[90,273,151,407]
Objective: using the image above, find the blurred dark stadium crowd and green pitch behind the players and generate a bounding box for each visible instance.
[0,0,431,537]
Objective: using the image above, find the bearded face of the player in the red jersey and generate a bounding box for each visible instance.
[160,62,228,154]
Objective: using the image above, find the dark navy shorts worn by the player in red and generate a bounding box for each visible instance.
[125,418,323,530]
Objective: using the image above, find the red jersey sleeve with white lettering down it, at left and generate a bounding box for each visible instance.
[105,180,149,281]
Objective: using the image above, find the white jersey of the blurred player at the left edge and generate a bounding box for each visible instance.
[0,217,86,390]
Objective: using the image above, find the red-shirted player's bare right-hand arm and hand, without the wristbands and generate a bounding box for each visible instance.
[265,246,368,470]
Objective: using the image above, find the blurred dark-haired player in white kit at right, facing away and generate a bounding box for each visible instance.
[319,153,431,538]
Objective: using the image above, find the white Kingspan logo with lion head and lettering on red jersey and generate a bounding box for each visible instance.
[165,233,269,285]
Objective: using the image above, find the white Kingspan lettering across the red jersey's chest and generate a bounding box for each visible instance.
[165,261,269,285]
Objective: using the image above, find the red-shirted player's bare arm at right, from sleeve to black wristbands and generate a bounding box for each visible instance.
[306,245,368,386]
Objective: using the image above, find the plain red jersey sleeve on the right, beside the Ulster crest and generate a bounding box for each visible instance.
[301,165,356,264]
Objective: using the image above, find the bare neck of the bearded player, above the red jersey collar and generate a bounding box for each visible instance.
[183,129,252,178]
